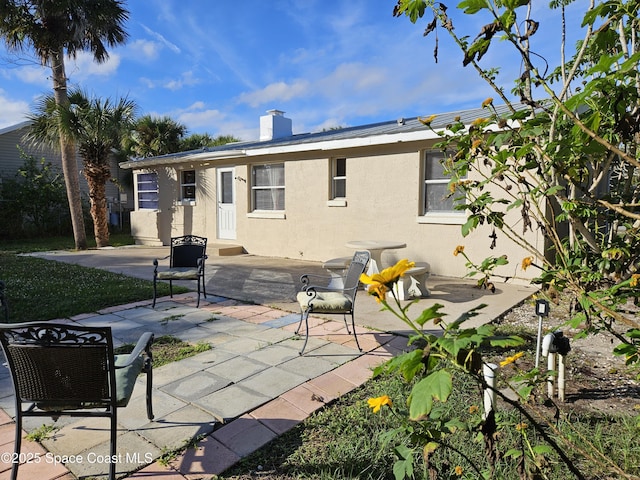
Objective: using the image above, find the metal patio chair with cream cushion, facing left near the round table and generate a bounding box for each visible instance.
[296,251,371,355]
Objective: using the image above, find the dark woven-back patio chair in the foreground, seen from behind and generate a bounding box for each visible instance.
[0,322,153,480]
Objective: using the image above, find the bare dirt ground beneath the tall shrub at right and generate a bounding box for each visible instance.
[496,303,640,415]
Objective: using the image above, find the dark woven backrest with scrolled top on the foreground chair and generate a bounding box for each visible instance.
[0,322,116,407]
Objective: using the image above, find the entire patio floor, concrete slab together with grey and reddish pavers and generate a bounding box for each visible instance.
[0,247,534,480]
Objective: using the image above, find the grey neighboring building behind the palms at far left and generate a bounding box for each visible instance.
[0,121,133,224]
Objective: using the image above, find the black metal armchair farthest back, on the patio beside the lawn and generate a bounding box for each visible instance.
[152,235,208,308]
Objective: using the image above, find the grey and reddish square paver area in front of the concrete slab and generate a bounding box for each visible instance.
[0,294,406,480]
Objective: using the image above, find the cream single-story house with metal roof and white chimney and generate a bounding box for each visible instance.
[120,105,542,276]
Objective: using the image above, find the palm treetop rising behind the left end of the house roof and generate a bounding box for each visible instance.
[126,115,187,158]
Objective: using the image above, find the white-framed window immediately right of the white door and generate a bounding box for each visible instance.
[251,163,284,211]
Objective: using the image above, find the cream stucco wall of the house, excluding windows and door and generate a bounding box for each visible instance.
[132,143,542,278]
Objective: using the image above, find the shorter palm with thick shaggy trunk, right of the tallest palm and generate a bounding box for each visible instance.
[29,90,136,247]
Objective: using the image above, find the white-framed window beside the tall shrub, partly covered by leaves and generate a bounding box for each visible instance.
[422,150,464,215]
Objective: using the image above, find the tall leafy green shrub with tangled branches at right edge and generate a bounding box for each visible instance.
[394,0,640,336]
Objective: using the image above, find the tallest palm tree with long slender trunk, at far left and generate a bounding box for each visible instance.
[0,0,129,250]
